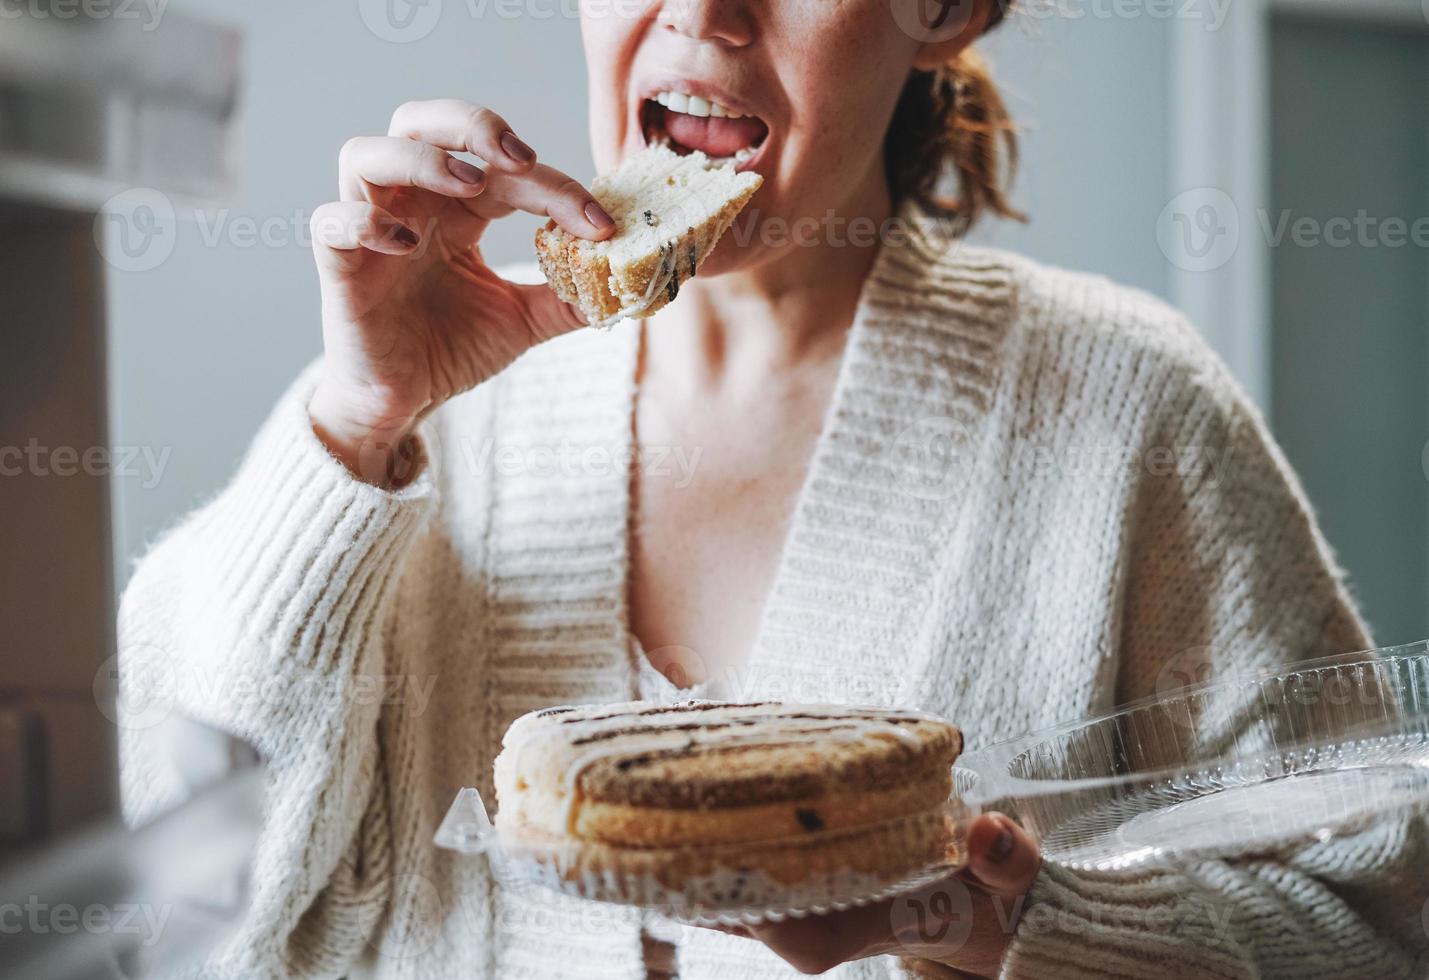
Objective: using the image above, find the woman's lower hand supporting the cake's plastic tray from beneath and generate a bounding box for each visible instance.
[725,813,1042,977]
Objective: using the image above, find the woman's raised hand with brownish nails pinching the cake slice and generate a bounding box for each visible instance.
[309,100,614,483]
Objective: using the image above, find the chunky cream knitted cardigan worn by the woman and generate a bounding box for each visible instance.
[120,218,1429,980]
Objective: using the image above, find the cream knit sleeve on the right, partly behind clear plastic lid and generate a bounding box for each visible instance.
[1003,365,1429,980]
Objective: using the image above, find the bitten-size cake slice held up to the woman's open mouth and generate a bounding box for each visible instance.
[536,143,763,326]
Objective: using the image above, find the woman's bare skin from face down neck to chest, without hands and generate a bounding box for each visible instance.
[582,0,977,683]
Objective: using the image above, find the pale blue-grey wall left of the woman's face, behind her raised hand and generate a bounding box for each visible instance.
[109,0,593,587]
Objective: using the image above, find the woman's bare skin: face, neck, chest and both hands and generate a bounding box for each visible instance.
[307,0,1039,974]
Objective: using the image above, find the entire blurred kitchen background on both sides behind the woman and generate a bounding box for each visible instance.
[0,0,1429,965]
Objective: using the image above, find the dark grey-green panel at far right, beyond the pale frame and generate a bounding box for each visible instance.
[1269,16,1429,644]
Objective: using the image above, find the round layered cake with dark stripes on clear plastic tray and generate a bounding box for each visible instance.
[496,701,962,901]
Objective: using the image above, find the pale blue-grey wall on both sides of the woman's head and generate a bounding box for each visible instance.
[109,0,1169,586]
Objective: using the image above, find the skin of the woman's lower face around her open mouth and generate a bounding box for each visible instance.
[582,0,920,276]
